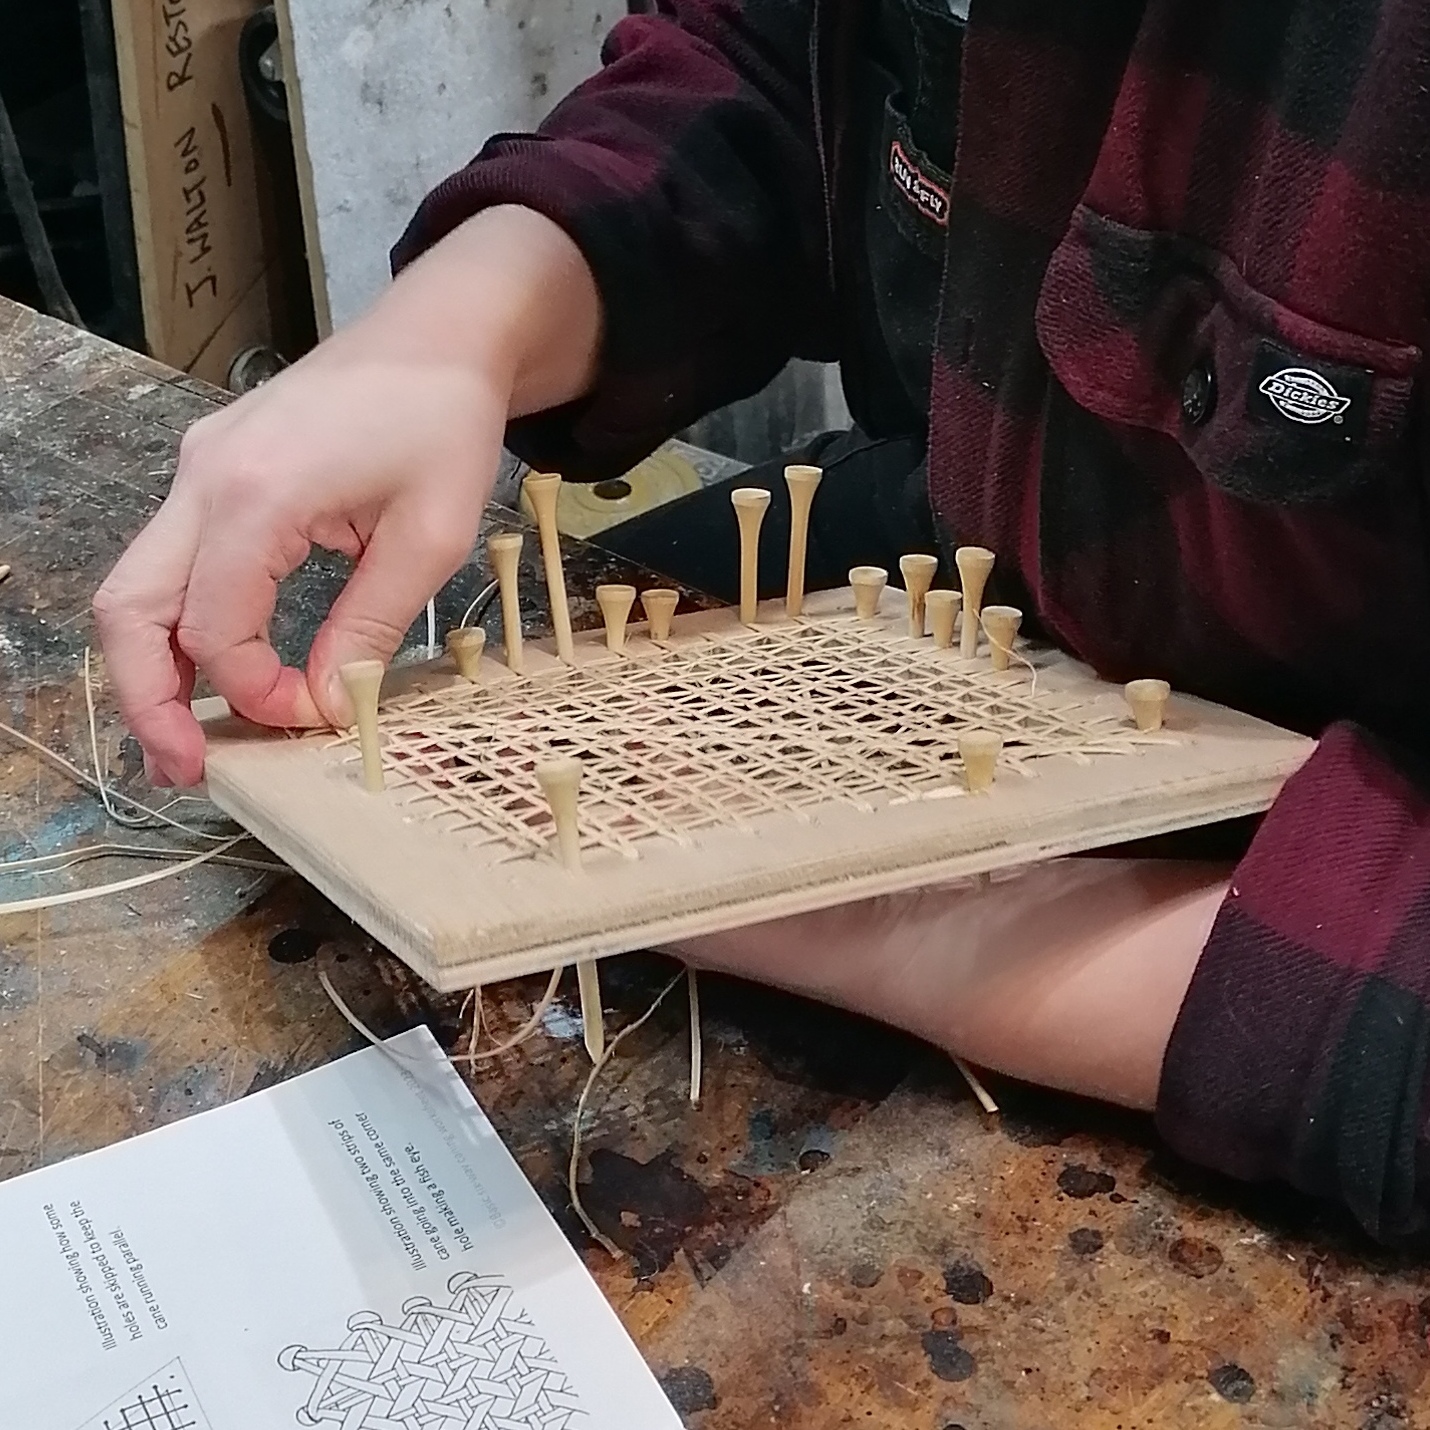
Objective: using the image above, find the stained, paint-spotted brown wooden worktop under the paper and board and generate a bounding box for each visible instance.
[0,299,1430,1430]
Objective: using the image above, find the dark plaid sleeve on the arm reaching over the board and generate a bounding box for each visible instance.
[395,0,834,479]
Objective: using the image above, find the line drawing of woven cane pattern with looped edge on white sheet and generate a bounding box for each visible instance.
[279,1273,586,1430]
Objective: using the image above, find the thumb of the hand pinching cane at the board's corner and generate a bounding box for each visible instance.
[307,501,478,726]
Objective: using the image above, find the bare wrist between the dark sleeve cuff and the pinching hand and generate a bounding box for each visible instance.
[360,207,602,418]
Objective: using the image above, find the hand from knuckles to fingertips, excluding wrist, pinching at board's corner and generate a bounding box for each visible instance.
[94,339,506,785]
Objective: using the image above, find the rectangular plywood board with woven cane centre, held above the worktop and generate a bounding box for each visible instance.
[198,591,1310,990]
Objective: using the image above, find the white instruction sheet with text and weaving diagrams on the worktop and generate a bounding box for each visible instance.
[0,1028,681,1430]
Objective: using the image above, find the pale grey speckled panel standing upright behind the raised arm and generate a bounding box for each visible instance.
[277,0,612,335]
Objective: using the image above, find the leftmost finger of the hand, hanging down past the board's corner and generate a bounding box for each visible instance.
[93,501,203,785]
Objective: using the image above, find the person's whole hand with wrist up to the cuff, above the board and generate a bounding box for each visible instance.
[94,209,599,785]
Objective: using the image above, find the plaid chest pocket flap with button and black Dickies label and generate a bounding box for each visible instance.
[1037,207,1421,506]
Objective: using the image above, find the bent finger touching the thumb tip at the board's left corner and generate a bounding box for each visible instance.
[177,512,323,726]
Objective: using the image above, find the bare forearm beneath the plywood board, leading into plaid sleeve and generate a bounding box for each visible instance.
[672,858,1228,1110]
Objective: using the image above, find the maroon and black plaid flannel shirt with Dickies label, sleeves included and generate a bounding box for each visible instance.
[395,0,1430,1243]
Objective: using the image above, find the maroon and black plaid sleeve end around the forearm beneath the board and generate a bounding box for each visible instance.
[1157,725,1430,1246]
